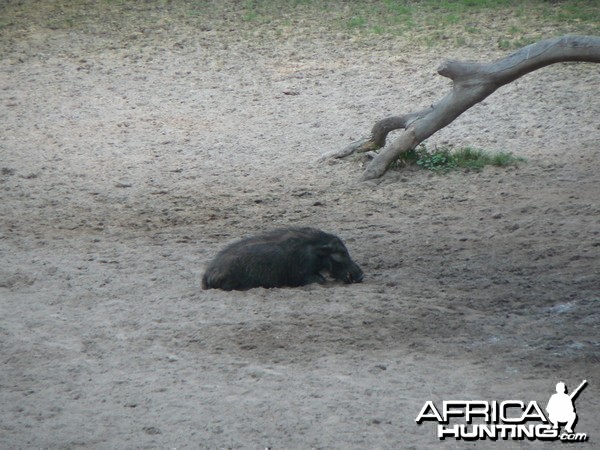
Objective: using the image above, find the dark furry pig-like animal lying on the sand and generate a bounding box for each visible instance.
[202,228,363,291]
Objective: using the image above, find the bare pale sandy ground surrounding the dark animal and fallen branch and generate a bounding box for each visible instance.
[0,2,600,448]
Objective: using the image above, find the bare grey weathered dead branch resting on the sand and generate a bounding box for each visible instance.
[323,36,600,180]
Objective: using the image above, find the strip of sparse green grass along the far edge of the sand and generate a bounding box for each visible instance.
[0,0,600,50]
